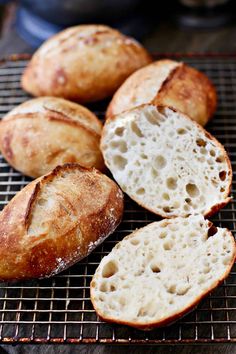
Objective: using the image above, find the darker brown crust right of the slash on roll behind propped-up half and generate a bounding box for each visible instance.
[156,64,217,126]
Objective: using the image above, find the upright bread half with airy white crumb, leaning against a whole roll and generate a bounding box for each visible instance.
[101,105,232,217]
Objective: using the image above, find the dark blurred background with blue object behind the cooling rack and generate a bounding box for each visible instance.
[0,0,236,57]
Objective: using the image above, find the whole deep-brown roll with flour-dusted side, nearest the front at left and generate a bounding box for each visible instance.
[0,164,123,281]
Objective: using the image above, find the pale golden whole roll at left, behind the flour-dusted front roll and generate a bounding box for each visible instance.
[0,97,104,177]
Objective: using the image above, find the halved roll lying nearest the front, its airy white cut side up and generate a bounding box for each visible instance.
[91,215,236,330]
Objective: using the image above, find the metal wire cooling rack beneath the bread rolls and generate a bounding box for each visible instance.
[0,56,236,344]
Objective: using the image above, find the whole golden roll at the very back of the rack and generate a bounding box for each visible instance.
[22,25,151,102]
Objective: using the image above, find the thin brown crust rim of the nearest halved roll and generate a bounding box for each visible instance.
[90,230,236,330]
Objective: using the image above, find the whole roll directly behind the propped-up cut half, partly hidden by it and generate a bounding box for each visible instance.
[107,59,217,125]
